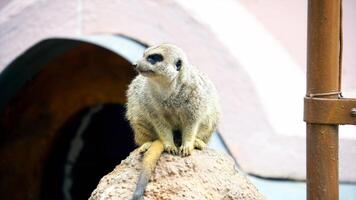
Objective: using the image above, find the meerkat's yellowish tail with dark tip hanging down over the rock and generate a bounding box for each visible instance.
[132,140,164,200]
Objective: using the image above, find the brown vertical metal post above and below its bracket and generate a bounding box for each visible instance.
[307,0,341,200]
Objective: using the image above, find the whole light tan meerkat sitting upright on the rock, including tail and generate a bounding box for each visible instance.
[126,44,220,199]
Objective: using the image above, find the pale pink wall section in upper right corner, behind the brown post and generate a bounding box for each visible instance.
[240,0,356,90]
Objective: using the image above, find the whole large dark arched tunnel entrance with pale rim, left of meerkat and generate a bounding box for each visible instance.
[0,36,145,199]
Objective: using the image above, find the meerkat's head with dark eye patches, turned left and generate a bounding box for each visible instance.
[136,44,187,80]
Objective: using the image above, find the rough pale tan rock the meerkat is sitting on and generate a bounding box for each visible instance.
[89,149,265,200]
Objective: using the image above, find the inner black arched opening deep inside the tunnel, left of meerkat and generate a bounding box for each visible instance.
[42,104,135,200]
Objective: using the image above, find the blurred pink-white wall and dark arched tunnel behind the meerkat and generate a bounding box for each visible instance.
[0,0,356,200]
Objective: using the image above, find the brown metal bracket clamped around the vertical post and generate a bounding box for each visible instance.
[304,97,356,125]
